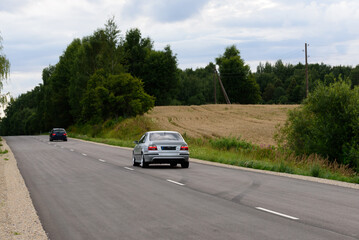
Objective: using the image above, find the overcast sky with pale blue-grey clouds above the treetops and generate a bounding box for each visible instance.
[0,0,359,96]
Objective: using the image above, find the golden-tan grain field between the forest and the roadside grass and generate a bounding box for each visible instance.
[146,104,298,145]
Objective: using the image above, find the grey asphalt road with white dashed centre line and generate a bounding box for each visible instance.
[5,136,359,240]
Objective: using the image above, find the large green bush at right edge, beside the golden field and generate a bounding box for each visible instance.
[276,79,359,172]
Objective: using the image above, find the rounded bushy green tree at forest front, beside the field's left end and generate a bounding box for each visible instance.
[82,69,154,122]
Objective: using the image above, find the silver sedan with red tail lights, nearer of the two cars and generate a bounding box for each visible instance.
[132,131,189,168]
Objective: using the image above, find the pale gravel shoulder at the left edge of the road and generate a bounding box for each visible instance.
[0,139,48,240]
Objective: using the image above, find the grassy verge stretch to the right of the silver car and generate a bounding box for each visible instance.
[188,138,359,183]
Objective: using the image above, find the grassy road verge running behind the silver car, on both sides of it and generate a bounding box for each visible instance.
[68,116,359,183]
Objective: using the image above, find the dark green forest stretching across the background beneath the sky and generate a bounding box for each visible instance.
[0,18,359,135]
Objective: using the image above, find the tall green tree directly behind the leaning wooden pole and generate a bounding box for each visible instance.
[216,45,261,104]
